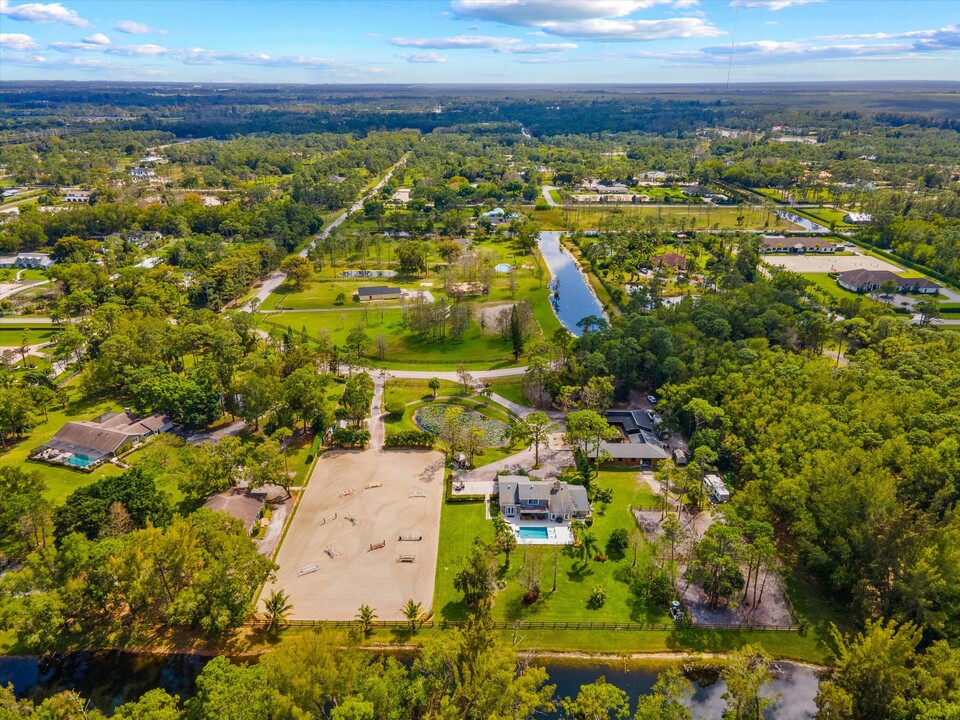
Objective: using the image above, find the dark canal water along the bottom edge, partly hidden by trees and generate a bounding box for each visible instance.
[0,651,818,720]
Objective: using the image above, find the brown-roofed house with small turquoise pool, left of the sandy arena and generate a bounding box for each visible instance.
[30,409,173,470]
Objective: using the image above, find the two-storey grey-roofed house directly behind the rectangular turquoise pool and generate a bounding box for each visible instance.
[497,475,590,522]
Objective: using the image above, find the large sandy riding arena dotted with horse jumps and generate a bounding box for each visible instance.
[263,450,443,620]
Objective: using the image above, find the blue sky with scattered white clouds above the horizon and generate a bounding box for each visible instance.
[0,0,960,83]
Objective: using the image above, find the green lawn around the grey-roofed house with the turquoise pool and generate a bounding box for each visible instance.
[434,470,667,622]
